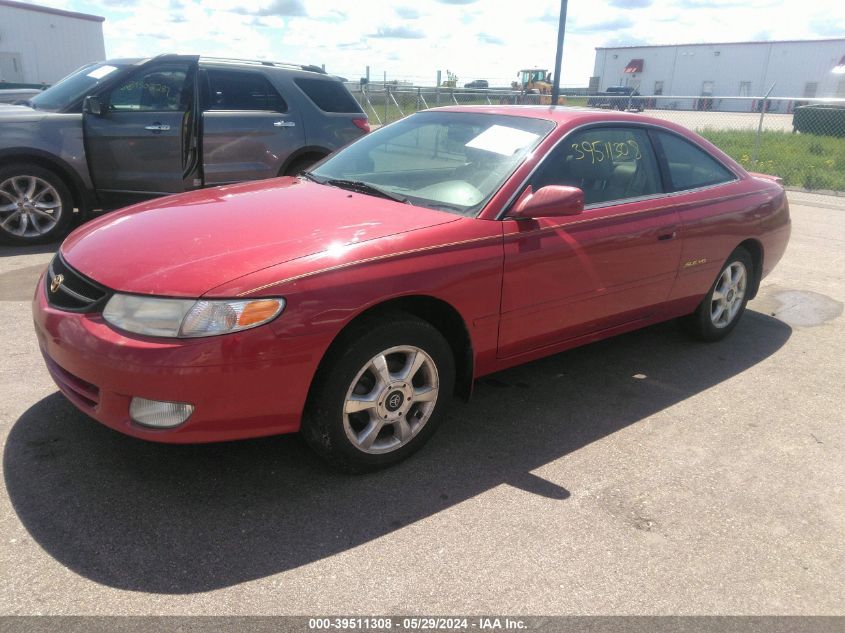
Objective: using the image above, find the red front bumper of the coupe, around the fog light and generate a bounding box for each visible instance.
[33,277,330,443]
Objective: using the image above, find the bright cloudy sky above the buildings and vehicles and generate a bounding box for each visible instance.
[44,0,845,86]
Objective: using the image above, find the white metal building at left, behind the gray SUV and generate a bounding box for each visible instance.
[0,0,106,86]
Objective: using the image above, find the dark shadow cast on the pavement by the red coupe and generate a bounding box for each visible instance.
[3,311,792,594]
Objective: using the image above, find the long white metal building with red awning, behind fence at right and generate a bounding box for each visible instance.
[591,39,845,103]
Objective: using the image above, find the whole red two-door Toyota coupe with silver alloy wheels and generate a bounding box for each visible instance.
[33,106,790,471]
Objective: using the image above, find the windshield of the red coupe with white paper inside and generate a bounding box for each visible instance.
[309,112,554,215]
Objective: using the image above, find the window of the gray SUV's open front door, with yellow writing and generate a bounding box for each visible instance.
[108,65,193,112]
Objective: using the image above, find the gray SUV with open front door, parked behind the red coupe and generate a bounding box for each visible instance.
[0,55,369,244]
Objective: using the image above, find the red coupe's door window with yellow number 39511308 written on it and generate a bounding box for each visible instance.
[531,127,663,204]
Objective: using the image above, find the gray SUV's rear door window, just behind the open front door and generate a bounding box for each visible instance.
[203,68,288,112]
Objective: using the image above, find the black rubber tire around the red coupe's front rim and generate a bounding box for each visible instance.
[302,312,455,473]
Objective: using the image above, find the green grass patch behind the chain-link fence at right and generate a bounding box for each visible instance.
[699,129,845,191]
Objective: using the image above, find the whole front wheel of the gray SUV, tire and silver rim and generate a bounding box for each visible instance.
[0,164,73,244]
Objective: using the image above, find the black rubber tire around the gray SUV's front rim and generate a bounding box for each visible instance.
[0,163,73,245]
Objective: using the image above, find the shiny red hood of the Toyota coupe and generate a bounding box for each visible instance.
[61,178,458,297]
